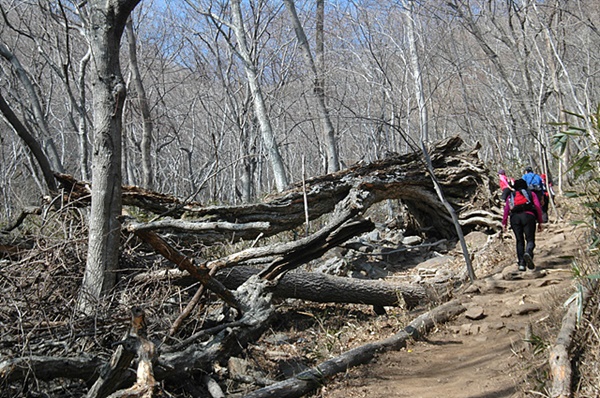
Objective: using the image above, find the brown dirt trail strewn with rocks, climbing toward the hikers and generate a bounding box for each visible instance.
[319,219,580,398]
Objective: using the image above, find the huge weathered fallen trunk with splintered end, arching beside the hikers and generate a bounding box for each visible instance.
[56,137,501,244]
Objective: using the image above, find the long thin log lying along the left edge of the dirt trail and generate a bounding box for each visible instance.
[245,301,466,398]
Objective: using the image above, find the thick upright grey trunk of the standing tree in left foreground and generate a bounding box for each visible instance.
[78,0,140,314]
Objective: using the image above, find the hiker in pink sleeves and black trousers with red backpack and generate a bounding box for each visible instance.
[502,178,542,271]
